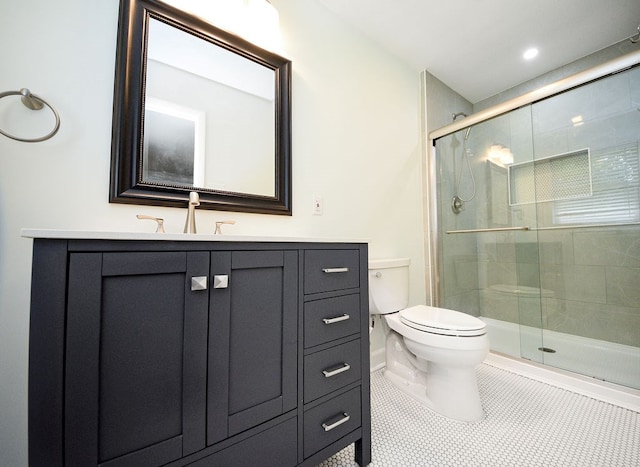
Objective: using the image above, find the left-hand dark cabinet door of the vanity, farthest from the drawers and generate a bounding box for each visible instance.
[65,252,209,467]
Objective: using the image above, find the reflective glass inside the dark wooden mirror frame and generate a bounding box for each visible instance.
[143,18,275,196]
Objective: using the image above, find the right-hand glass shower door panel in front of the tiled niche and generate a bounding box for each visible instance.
[531,67,640,388]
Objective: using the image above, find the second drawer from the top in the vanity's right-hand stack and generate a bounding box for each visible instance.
[304,294,360,348]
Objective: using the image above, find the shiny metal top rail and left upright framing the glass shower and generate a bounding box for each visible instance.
[423,50,640,306]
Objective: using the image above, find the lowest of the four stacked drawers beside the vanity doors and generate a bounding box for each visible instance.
[304,387,361,457]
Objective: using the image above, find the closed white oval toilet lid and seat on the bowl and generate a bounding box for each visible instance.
[400,305,487,336]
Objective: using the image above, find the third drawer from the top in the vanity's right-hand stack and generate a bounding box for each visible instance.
[304,339,361,403]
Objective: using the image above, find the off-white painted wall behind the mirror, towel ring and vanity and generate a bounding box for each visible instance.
[0,0,425,466]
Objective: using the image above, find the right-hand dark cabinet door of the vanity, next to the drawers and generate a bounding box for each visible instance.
[207,251,298,444]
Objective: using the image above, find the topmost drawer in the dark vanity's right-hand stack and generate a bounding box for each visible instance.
[304,250,360,294]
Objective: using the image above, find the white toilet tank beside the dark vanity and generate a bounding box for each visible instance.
[369,258,410,315]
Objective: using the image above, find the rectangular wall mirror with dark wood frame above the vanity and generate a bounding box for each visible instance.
[109,0,291,215]
